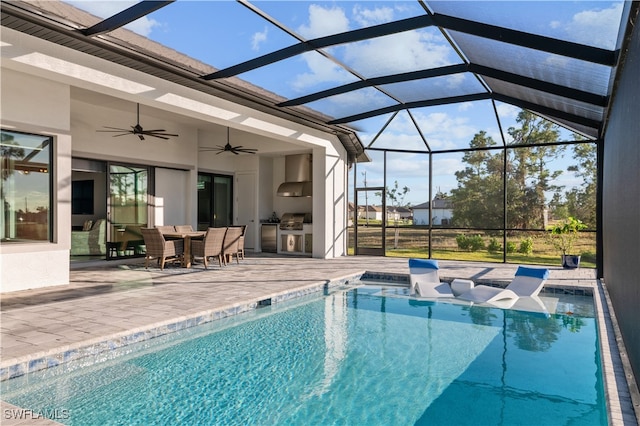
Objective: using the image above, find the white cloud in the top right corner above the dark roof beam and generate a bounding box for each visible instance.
[565,2,624,49]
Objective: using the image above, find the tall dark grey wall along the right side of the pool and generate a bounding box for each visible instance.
[602,14,640,378]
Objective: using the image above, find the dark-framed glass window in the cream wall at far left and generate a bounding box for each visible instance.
[0,130,53,243]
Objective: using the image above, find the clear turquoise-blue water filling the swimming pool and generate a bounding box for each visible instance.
[2,286,607,425]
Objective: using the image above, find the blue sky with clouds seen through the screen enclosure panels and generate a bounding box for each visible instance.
[69,0,622,205]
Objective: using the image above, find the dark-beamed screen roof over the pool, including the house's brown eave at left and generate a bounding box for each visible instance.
[2,0,637,158]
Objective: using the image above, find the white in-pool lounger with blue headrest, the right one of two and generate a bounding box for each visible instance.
[458,266,549,307]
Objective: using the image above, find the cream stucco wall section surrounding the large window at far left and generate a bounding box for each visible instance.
[0,68,71,292]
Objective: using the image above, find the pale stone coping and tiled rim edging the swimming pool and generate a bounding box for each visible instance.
[0,270,640,426]
